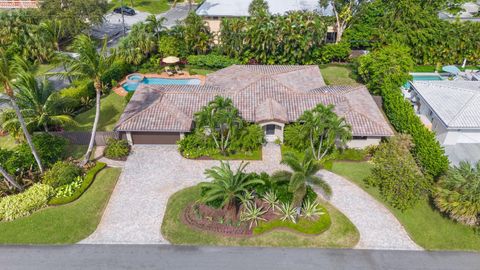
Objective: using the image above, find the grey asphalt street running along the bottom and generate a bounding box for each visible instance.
[0,245,480,270]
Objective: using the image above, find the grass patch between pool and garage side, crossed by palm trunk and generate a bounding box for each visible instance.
[68,92,126,131]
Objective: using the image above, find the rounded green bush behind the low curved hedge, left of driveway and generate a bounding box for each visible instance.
[42,161,82,188]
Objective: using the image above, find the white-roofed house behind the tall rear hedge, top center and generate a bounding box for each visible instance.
[196,0,335,42]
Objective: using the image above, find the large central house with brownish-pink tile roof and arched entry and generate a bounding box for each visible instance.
[115,65,393,148]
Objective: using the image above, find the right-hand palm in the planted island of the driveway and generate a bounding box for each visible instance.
[272,151,332,207]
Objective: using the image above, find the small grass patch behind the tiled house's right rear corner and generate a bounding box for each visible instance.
[320,64,358,85]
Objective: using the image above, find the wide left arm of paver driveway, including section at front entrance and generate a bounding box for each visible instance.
[82,144,281,244]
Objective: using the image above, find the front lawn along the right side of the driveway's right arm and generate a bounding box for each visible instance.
[332,162,480,251]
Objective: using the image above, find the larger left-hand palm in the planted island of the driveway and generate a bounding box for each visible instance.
[202,161,264,214]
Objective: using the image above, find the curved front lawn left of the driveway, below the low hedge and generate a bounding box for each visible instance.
[0,168,121,244]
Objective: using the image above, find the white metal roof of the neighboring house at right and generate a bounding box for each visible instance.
[412,81,480,129]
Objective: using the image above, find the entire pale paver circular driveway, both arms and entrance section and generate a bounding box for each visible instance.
[82,144,419,249]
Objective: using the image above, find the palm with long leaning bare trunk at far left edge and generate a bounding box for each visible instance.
[0,49,43,173]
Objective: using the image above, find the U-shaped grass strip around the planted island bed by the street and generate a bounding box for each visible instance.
[161,186,359,248]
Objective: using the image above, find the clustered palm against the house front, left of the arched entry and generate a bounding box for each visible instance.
[195,96,243,155]
